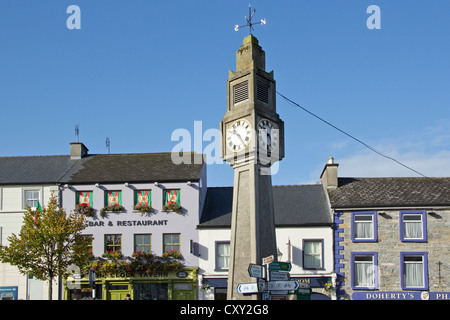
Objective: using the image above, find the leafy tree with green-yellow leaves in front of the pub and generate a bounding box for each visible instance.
[0,193,91,300]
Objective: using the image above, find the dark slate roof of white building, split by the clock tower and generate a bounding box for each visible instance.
[198,185,331,228]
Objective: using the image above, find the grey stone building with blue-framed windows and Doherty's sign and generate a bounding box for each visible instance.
[321,158,450,300]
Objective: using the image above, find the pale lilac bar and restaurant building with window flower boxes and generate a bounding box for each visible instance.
[61,143,206,300]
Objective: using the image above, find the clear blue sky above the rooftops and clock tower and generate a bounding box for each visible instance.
[0,0,450,186]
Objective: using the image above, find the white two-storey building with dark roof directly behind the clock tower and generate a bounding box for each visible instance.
[198,185,336,300]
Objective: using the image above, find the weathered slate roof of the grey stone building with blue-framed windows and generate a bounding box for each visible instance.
[328,178,450,209]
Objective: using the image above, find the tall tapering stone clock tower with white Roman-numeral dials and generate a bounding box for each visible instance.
[220,34,284,300]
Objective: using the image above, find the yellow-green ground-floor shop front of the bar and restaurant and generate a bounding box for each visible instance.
[64,268,198,300]
